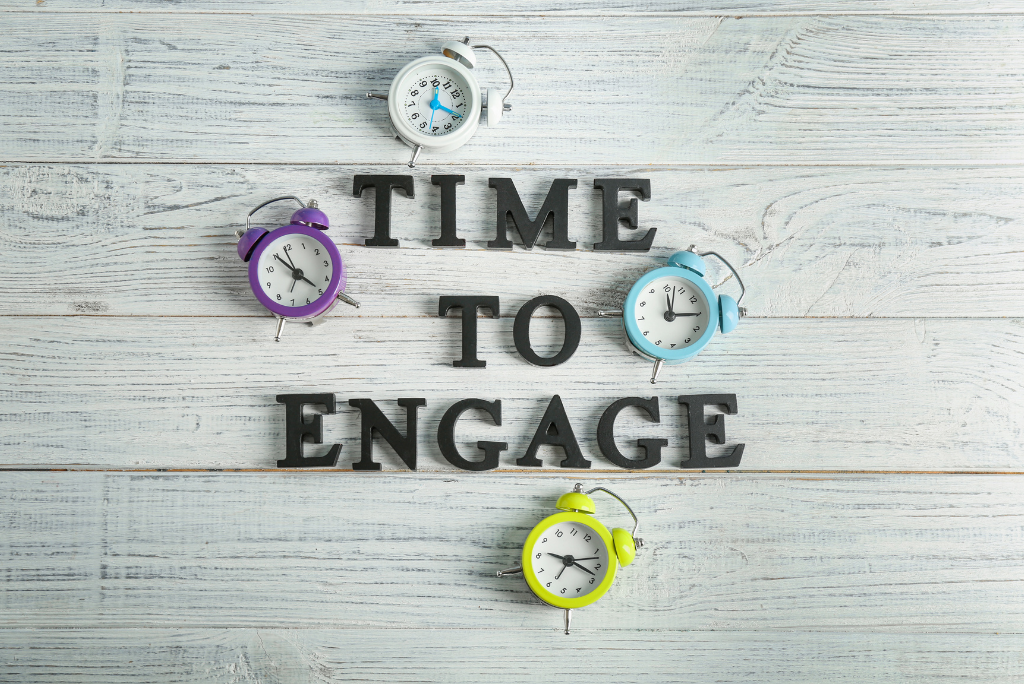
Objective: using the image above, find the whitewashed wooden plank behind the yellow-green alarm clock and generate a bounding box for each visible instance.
[0,473,1024,634]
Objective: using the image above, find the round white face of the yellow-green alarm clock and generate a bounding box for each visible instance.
[527,522,615,598]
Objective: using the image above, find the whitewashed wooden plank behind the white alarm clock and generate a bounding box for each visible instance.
[0,12,1024,165]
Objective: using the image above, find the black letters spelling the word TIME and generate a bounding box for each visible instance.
[352,175,657,252]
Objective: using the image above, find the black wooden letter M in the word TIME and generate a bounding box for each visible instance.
[487,178,577,250]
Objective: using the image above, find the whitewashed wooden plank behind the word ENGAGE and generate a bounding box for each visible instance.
[0,317,1024,473]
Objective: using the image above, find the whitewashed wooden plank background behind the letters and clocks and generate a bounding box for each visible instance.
[0,0,1024,684]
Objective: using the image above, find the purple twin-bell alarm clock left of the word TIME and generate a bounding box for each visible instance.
[236,196,359,341]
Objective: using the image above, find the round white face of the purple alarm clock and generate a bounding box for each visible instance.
[259,233,334,306]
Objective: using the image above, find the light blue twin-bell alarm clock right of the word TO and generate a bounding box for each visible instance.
[598,245,746,384]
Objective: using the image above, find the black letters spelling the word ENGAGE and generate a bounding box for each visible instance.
[278,394,743,471]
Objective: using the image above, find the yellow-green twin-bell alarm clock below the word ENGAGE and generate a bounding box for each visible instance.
[498,483,643,634]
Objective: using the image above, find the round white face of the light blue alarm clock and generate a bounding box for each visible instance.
[633,275,711,349]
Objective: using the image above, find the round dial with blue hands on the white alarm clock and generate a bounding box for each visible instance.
[399,65,470,136]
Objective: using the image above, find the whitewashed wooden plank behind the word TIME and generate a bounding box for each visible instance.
[0,164,1024,318]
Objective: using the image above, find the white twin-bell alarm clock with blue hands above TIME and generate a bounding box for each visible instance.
[367,37,515,167]
